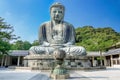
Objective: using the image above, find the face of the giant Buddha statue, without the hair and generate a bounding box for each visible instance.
[51,7,64,21]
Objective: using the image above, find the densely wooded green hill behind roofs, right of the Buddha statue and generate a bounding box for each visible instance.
[76,26,120,51]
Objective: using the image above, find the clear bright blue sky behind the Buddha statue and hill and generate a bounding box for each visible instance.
[0,0,120,42]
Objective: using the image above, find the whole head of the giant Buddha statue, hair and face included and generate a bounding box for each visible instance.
[50,3,65,22]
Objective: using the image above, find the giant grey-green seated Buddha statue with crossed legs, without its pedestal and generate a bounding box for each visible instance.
[29,3,86,55]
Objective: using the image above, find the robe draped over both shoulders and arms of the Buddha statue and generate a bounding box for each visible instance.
[39,22,75,45]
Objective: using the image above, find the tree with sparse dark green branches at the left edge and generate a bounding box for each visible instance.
[0,17,18,54]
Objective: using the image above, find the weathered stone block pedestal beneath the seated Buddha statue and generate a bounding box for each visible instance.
[24,54,91,70]
